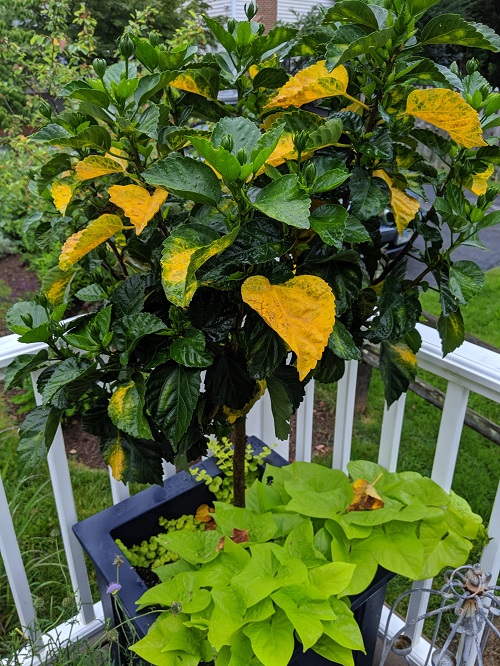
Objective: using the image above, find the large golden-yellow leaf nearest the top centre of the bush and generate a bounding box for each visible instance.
[265,60,349,109]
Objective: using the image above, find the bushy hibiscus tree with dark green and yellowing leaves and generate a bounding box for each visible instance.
[7,0,500,504]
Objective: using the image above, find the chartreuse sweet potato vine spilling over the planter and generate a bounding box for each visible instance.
[132,461,481,666]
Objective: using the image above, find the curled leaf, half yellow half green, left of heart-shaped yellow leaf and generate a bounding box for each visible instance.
[161,224,238,308]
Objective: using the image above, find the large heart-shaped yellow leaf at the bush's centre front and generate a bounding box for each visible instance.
[241,275,335,380]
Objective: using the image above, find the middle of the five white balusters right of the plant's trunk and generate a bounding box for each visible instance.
[332,361,358,473]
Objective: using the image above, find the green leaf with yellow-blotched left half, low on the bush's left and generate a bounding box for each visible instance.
[108,375,154,439]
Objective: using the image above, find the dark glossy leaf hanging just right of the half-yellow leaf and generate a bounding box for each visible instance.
[147,365,201,448]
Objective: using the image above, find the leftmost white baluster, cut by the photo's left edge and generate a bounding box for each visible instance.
[0,477,38,641]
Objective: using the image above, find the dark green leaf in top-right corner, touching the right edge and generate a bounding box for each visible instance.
[420,14,500,52]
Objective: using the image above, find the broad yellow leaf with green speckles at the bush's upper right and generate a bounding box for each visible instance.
[406,88,487,148]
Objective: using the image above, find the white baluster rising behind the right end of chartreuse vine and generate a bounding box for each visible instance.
[406,382,469,645]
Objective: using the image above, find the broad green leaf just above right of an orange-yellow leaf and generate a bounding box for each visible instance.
[142,153,222,206]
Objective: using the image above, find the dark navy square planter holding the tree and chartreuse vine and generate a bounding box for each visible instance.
[73,437,393,666]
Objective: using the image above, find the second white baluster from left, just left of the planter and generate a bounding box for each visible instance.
[31,373,95,624]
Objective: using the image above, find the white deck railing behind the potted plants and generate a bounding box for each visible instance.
[0,326,500,666]
